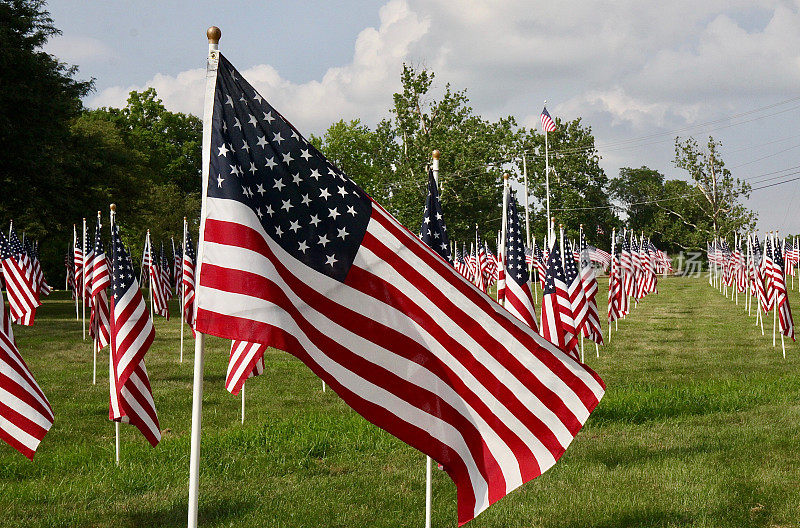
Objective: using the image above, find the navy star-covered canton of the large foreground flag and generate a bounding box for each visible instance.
[207,55,372,281]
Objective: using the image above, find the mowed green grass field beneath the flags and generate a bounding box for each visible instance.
[0,278,800,528]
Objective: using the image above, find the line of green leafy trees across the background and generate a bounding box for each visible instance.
[0,0,755,284]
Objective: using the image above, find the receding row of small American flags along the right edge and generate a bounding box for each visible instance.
[706,233,800,346]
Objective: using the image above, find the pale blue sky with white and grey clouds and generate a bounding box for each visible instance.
[46,0,800,233]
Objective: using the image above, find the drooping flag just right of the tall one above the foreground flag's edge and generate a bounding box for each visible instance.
[541,244,578,361]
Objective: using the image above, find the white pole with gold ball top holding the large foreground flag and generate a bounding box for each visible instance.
[187,26,217,528]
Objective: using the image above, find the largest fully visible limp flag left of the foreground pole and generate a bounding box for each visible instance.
[108,220,161,447]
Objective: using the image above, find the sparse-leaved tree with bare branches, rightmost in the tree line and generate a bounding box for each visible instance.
[662,136,756,238]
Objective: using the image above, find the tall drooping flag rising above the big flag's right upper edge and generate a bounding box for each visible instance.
[503,190,539,332]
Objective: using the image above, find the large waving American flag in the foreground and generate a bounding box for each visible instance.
[196,56,604,523]
